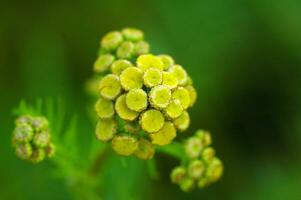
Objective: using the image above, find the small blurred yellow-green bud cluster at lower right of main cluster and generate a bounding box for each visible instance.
[170,130,223,192]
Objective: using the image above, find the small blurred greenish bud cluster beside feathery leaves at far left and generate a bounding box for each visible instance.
[13,115,55,163]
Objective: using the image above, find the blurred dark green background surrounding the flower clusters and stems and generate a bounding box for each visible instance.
[0,0,301,200]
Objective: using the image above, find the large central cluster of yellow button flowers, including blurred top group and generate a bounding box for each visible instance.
[94,28,197,159]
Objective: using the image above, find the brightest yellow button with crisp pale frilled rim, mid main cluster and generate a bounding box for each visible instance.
[149,85,171,108]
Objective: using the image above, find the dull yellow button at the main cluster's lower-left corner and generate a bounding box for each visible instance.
[95,119,117,142]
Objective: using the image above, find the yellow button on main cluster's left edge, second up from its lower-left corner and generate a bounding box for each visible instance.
[94,97,115,119]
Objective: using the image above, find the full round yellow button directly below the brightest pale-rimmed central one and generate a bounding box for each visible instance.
[140,109,164,133]
